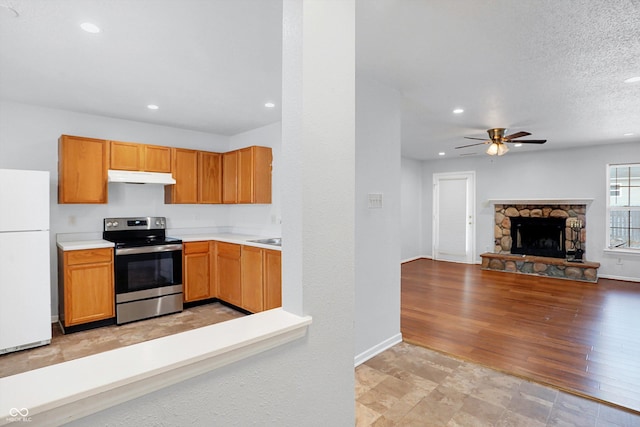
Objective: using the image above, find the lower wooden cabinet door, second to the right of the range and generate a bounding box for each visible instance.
[216,242,242,307]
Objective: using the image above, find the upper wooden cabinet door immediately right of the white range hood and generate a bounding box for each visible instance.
[164,148,198,203]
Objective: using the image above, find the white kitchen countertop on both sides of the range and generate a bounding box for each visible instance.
[57,232,282,251]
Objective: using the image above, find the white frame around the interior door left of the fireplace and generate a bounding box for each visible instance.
[431,171,476,264]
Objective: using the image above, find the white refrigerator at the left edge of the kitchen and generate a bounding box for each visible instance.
[0,169,51,354]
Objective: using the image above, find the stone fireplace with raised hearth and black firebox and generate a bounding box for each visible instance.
[480,201,600,282]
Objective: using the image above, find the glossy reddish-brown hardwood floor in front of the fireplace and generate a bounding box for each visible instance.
[401,259,640,412]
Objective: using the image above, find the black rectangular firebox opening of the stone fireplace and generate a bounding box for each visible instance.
[510,217,566,258]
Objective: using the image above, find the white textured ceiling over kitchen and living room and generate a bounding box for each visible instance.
[0,0,640,159]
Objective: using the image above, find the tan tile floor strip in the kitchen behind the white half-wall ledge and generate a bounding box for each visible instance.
[0,302,244,378]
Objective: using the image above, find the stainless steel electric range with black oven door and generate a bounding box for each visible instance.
[102,217,183,324]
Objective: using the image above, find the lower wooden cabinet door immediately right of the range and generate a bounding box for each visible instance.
[183,242,210,301]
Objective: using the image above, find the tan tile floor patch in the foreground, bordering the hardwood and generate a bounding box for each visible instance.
[355,343,640,427]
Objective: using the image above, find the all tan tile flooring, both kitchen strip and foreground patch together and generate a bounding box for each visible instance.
[6,303,640,427]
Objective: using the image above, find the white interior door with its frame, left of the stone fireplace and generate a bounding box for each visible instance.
[433,171,475,264]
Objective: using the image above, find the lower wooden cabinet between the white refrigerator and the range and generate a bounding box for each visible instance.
[58,248,115,327]
